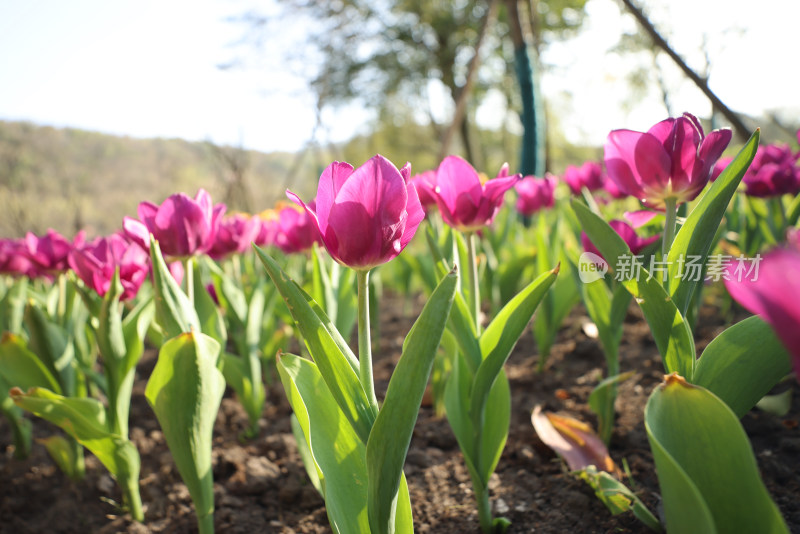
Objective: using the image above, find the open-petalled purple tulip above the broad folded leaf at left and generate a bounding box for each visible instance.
[122,189,225,258]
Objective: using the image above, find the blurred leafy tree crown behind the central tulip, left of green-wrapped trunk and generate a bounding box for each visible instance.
[223,0,586,176]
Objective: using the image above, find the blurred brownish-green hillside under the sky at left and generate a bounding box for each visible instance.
[0,121,319,237]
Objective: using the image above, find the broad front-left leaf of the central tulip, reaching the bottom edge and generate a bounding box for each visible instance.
[278,354,370,534]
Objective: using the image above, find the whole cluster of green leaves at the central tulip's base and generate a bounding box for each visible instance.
[256,248,456,533]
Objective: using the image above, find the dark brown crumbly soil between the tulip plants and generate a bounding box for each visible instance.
[0,297,800,534]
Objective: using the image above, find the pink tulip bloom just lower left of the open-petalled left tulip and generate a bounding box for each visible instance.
[68,233,150,300]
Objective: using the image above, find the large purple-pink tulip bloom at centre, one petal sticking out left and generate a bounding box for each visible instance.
[287,155,425,271]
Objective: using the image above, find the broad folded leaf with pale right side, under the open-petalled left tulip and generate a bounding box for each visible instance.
[145,332,225,532]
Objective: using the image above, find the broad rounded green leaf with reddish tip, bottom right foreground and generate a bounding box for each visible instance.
[644,374,788,534]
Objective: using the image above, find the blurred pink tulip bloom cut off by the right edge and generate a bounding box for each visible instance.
[724,229,800,379]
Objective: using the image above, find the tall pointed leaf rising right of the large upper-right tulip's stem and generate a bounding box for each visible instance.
[667,129,760,315]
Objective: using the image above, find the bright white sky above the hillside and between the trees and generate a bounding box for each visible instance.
[0,0,800,155]
